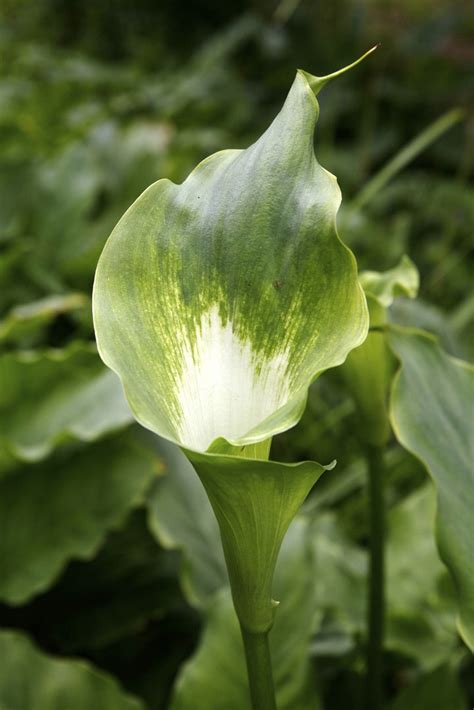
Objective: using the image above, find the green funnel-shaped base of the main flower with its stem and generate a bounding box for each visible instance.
[186,454,328,710]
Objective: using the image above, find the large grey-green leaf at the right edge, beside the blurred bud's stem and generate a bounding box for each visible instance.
[389,328,474,648]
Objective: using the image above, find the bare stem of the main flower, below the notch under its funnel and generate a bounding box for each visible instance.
[241,627,276,710]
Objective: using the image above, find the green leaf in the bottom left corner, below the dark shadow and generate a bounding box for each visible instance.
[0,631,144,710]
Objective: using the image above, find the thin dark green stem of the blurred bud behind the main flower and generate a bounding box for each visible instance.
[367,445,385,710]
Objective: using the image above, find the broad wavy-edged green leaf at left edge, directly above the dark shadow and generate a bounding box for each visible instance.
[0,437,159,604]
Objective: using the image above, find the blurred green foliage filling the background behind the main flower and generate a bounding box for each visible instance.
[0,0,474,710]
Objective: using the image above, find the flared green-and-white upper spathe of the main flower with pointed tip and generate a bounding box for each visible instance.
[93,50,374,452]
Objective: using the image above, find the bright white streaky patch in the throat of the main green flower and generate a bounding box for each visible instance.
[177,306,289,451]
